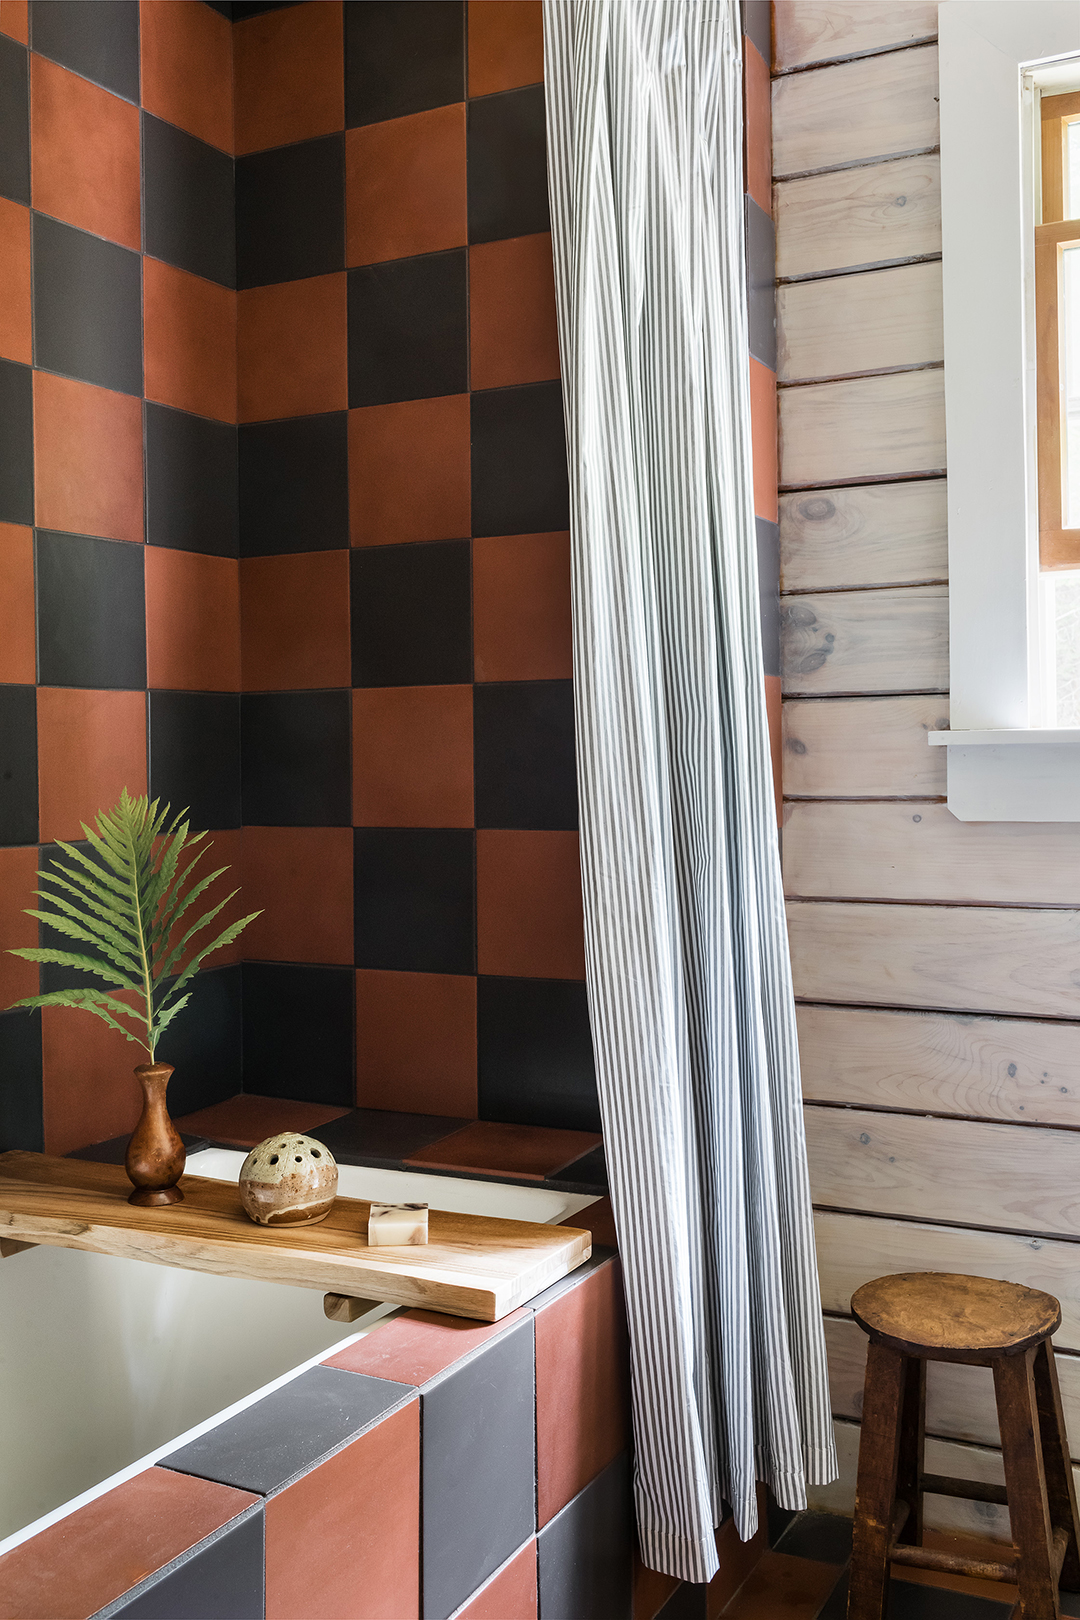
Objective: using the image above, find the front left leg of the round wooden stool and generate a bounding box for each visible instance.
[847,1340,907,1620]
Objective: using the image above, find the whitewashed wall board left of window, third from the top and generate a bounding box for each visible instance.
[772,154,941,277]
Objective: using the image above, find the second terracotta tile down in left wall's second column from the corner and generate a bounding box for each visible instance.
[34,371,142,543]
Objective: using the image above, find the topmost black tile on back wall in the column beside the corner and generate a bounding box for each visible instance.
[236,134,345,287]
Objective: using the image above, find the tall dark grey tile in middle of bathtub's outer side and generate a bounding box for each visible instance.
[421,1315,537,1620]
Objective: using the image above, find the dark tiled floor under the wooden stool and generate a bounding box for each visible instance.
[722,1513,1080,1620]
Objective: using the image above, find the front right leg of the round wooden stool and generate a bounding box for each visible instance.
[994,1349,1057,1620]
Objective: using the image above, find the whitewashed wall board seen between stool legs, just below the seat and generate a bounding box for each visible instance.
[826,1317,1080,1460]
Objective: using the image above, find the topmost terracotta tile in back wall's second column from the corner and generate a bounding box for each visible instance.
[345,102,468,264]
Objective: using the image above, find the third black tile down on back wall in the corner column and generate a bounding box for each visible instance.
[240,692,353,826]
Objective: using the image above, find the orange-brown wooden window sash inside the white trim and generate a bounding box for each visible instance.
[1035,91,1080,570]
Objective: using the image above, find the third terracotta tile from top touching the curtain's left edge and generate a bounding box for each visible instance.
[473,533,573,680]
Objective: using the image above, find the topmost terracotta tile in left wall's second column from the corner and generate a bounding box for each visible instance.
[31,52,142,253]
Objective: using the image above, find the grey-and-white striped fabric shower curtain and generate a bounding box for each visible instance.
[544,0,836,1581]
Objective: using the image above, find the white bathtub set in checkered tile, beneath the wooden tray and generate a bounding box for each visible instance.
[0,1149,596,1554]
